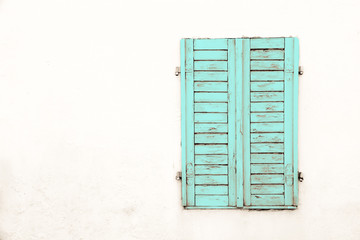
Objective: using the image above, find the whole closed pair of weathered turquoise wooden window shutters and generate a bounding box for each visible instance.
[181,38,299,209]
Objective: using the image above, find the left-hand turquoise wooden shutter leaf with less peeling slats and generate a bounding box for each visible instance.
[181,39,237,207]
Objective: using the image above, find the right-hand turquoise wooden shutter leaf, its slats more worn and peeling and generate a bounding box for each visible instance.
[243,38,299,208]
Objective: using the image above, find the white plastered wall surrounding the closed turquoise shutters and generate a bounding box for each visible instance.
[0,0,360,240]
